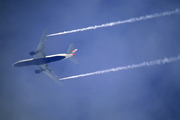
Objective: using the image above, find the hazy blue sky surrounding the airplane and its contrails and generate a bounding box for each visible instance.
[0,0,180,120]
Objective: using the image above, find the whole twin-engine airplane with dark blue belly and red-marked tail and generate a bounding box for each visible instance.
[13,30,78,84]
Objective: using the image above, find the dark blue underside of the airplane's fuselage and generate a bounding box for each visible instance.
[14,56,65,67]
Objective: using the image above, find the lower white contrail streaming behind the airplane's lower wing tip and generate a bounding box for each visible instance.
[59,55,180,80]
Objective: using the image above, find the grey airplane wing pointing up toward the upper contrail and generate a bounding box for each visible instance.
[34,29,47,59]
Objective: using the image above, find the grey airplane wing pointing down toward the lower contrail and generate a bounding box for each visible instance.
[38,64,62,85]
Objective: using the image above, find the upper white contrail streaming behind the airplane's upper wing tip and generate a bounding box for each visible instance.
[47,9,180,36]
